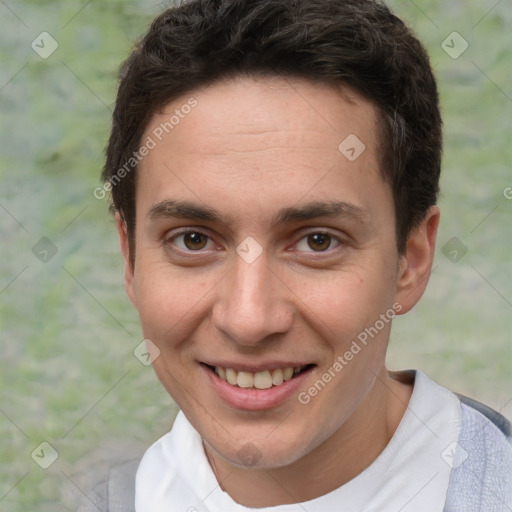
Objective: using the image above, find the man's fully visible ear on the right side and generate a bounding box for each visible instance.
[396,206,441,315]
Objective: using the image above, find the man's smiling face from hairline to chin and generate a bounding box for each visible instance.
[118,78,434,467]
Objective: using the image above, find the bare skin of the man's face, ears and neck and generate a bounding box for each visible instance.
[116,78,439,507]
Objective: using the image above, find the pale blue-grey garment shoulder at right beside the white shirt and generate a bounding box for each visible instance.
[445,395,512,512]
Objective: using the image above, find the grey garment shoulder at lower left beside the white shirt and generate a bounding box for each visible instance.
[76,458,140,512]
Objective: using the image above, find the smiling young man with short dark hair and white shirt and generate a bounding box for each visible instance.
[78,0,512,512]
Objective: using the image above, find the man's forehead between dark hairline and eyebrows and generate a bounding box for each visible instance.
[137,78,389,226]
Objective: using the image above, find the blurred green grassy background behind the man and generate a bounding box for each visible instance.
[0,0,512,512]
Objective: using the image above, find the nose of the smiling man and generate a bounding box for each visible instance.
[212,254,293,347]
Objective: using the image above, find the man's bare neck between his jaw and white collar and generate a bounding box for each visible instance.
[205,367,412,508]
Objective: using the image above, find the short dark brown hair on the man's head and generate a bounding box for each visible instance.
[102,0,442,262]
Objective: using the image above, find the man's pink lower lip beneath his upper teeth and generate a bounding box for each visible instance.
[200,364,314,411]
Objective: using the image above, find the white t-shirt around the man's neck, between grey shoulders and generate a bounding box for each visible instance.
[135,371,461,512]
